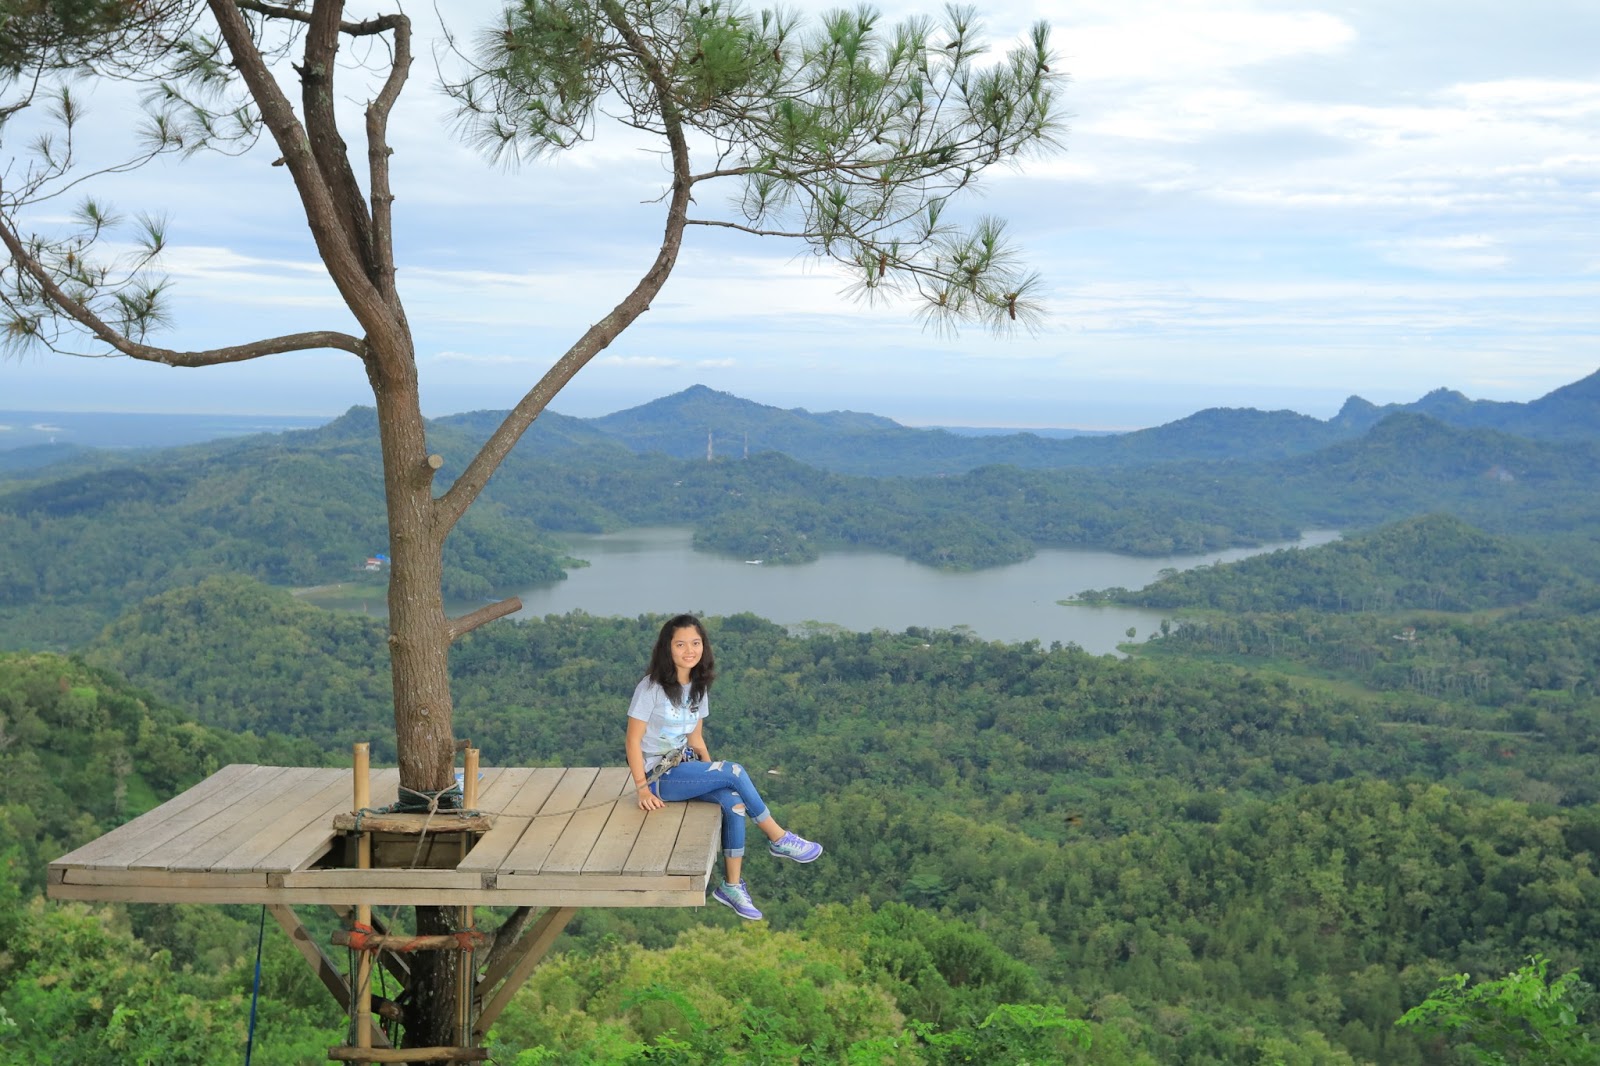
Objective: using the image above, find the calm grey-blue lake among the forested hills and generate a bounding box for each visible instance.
[517,527,1339,655]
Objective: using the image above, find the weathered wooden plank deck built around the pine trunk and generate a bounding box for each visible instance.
[46,765,722,908]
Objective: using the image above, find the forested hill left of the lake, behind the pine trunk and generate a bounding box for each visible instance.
[0,408,562,648]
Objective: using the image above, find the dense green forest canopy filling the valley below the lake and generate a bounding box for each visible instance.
[0,578,1600,1066]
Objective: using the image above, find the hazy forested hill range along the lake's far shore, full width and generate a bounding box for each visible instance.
[0,400,1600,647]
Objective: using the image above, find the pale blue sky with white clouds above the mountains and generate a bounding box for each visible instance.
[0,0,1600,429]
